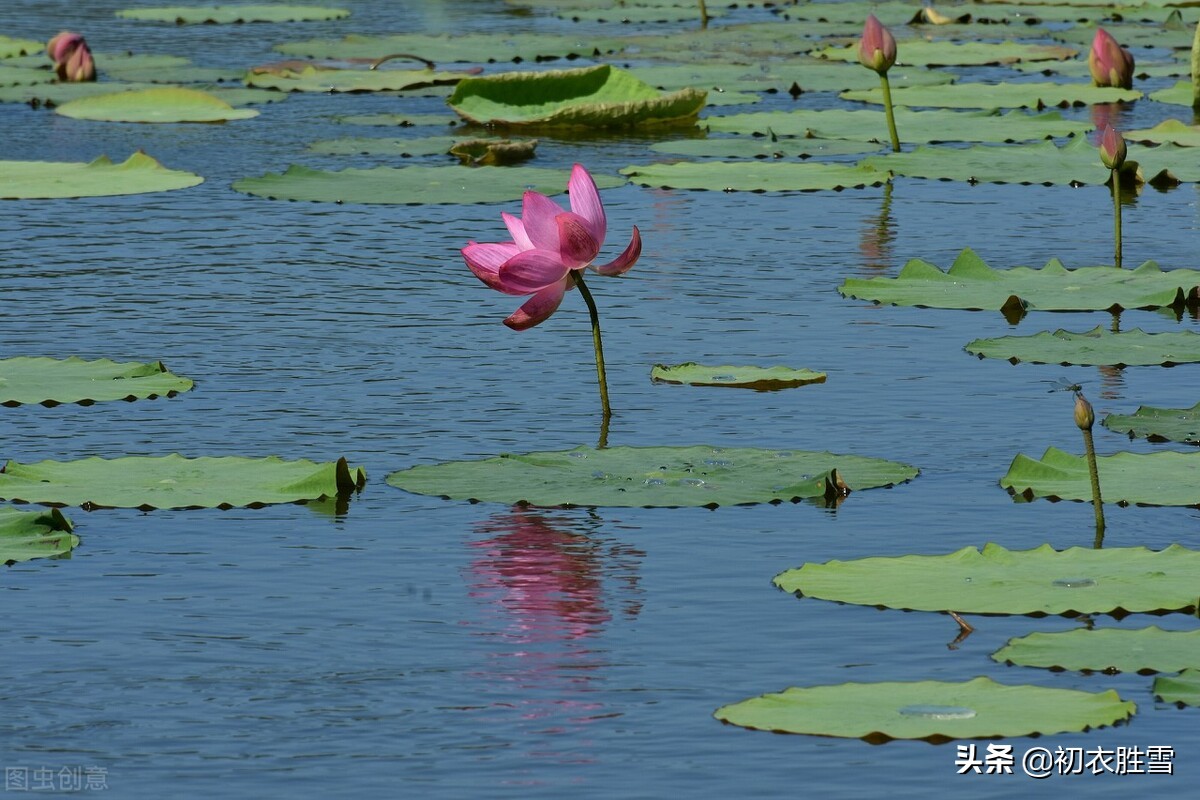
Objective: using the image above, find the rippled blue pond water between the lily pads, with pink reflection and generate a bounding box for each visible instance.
[0,0,1200,798]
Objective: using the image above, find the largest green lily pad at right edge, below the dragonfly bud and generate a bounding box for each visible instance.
[774,542,1200,616]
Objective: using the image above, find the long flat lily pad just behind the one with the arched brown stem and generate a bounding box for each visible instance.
[275,32,625,64]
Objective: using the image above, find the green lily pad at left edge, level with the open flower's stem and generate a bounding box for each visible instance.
[0,357,192,405]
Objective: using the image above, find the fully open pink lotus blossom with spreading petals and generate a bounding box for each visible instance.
[462,164,642,331]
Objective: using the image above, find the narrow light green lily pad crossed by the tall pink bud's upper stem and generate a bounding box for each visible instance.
[840,83,1141,110]
